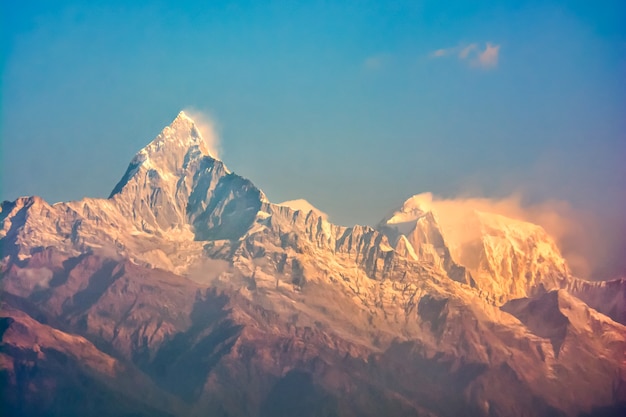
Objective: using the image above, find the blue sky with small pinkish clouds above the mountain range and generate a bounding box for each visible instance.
[0,0,626,231]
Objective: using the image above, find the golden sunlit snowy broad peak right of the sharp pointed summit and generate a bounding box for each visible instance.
[379,193,570,304]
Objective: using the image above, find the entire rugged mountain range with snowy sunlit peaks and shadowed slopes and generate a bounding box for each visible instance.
[0,113,626,417]
